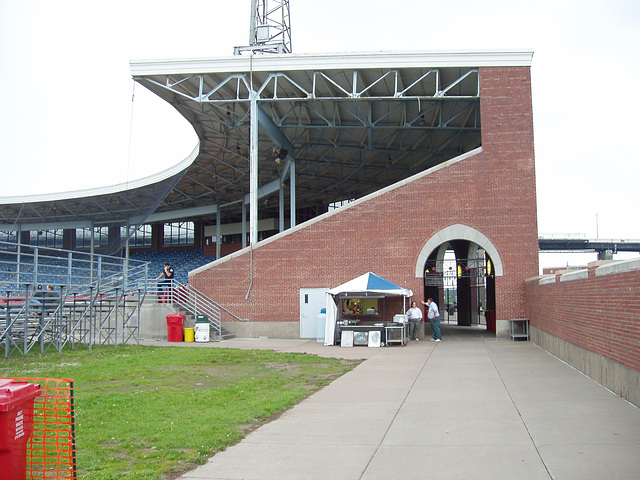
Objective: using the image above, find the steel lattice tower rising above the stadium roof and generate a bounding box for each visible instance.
[233,0,292,55]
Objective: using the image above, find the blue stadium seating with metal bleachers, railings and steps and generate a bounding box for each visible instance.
[0,242,223,357]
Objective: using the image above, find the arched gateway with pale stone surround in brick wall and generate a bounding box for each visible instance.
[416,225,502,332]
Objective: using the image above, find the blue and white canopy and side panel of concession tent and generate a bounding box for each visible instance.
[324,272,413,345]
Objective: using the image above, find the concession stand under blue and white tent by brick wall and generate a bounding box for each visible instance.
[324,272,413,346]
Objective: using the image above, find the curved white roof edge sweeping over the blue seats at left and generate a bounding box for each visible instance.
[0,141,200,205]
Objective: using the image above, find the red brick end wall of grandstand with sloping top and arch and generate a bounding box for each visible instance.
[190,67,538,332]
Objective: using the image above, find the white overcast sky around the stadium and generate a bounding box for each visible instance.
[0,0,640,265]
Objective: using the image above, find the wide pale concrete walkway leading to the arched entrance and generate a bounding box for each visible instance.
[145,325,640,480]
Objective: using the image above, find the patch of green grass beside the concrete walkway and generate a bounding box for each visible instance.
[0,346,360,480]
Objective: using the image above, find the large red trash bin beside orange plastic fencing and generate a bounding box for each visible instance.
[0,378,40,478]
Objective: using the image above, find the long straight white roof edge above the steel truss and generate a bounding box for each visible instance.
[129,49,533,76]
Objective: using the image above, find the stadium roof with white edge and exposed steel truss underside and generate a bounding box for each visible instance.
[0,50,533,240]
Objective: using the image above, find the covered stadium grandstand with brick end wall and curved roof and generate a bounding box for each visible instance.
[0,0,538,338]
